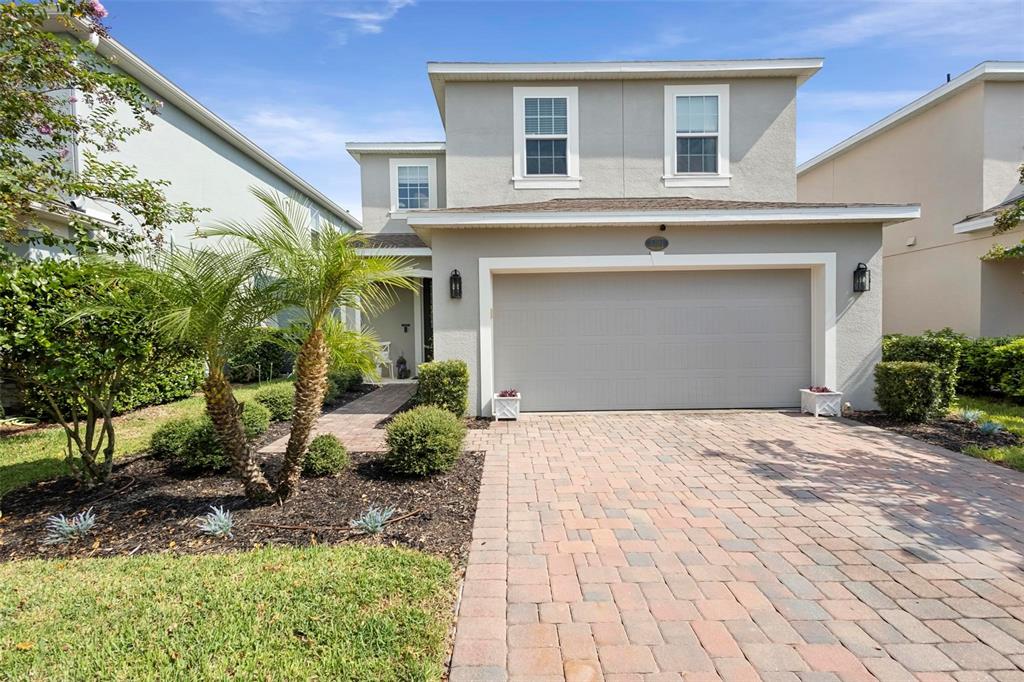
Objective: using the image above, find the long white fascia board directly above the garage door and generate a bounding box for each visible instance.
[407,205,921,227]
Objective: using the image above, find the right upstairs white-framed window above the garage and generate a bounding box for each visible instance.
[663,85,731,187]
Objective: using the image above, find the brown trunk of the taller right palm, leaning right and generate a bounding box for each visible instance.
[278,327,328,499]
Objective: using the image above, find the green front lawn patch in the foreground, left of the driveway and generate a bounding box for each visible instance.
[0,545,455,680]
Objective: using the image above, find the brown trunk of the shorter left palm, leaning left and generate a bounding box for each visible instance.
[203,367,273,502]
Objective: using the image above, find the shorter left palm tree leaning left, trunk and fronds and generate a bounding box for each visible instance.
[108,248,283,502]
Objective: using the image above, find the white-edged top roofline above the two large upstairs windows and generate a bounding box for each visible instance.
[427,57,823,124]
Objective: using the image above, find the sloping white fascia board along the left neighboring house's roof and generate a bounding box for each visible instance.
[54,20,362,230]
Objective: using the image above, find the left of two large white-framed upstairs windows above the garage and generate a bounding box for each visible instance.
[512,87,580,189]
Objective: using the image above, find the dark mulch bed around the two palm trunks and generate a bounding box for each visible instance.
[0,382,484,566]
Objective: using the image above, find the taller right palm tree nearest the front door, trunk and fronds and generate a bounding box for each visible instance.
[201,187,417,498]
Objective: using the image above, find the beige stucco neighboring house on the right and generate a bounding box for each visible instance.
[797,61,1024,336]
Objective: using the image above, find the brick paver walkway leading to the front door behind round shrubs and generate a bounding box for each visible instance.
[260,383,416,453]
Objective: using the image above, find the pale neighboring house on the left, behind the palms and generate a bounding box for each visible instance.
[19,27,361,256]
